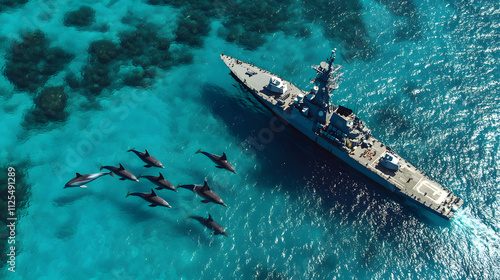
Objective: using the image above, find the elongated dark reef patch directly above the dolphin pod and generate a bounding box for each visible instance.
[72,19,177,97]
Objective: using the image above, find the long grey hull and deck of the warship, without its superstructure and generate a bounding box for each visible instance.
[221,54,463,220]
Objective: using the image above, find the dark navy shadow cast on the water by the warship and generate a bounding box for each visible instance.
[201,84,446,232]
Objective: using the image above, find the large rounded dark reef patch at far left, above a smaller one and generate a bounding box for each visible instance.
[4,30,74,93]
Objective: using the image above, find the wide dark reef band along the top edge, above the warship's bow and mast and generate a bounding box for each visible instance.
[148,0,376,60]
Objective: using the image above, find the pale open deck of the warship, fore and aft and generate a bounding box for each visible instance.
[221,54,463,219]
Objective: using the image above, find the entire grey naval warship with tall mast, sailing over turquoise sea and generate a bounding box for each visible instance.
[220,51,463,220]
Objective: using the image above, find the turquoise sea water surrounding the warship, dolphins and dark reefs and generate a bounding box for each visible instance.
[0,0,500,279]
